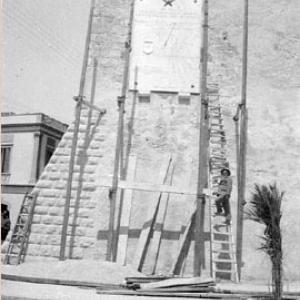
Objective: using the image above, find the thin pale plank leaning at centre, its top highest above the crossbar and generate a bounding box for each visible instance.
[149,165,174,274]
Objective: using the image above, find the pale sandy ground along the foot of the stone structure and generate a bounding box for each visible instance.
[1,260,300,300]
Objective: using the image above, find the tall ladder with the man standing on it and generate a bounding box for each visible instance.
[208,93,238,282]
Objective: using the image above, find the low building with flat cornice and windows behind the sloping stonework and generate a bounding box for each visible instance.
[1,113,68,229]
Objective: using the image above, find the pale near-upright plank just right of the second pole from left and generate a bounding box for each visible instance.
[117,155,137,265]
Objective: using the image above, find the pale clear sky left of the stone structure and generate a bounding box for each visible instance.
[1,0,90,123]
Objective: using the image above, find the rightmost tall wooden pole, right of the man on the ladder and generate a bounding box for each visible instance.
[236,0,249,280]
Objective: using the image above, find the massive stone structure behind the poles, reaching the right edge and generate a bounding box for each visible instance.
[2,0,300,280]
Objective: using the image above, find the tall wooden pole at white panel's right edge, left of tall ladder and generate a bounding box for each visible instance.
[194,0,208,276]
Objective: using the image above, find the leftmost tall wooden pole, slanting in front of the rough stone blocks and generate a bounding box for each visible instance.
[59,0,95,260]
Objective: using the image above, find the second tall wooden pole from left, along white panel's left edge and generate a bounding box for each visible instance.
[106,0,134,261]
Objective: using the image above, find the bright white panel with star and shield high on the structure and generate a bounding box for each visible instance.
[130,0,202,93]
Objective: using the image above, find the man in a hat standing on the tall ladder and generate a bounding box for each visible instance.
[215,167,232,225]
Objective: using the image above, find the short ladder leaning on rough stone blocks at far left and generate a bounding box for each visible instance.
[4,194,37,265]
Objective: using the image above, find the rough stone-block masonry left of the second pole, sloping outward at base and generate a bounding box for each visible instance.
[23,0,130,259]
